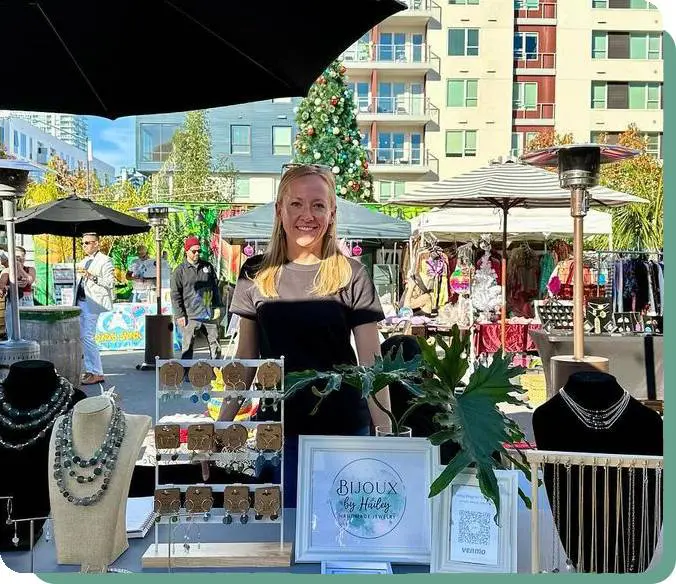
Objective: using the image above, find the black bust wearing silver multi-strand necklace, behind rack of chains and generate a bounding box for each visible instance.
[533,371,663,572]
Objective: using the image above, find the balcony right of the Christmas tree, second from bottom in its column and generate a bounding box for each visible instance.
[357,95,439,126]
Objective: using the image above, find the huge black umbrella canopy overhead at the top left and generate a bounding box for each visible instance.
[0,0,406,119]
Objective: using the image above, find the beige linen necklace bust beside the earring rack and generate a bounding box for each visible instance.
[48,396,151,572]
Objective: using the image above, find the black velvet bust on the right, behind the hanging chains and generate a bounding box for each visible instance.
[533,371,663,572]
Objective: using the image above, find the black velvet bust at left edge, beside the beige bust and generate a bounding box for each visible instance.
[0,359,86,550]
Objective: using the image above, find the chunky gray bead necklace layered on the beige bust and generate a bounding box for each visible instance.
[53,405,126,507]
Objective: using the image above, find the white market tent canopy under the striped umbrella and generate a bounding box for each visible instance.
[411,207,612,241]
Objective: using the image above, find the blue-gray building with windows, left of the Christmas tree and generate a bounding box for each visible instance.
[136,98,300,204]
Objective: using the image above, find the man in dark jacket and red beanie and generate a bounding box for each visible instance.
[171,236,221,359]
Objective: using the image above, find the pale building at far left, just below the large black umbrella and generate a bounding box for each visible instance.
[0,117,115,186]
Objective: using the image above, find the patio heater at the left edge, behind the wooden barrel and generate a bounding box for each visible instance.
[0,159,40,379]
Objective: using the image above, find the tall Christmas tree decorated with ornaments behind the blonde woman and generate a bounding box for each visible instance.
[294,61,373,202]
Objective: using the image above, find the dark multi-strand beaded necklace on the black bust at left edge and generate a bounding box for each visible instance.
[0,377,75,450]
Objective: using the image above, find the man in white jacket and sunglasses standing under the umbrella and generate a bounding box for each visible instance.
[73,233,115,385]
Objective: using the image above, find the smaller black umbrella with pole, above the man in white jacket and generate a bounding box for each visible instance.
[15,196,150,304]
